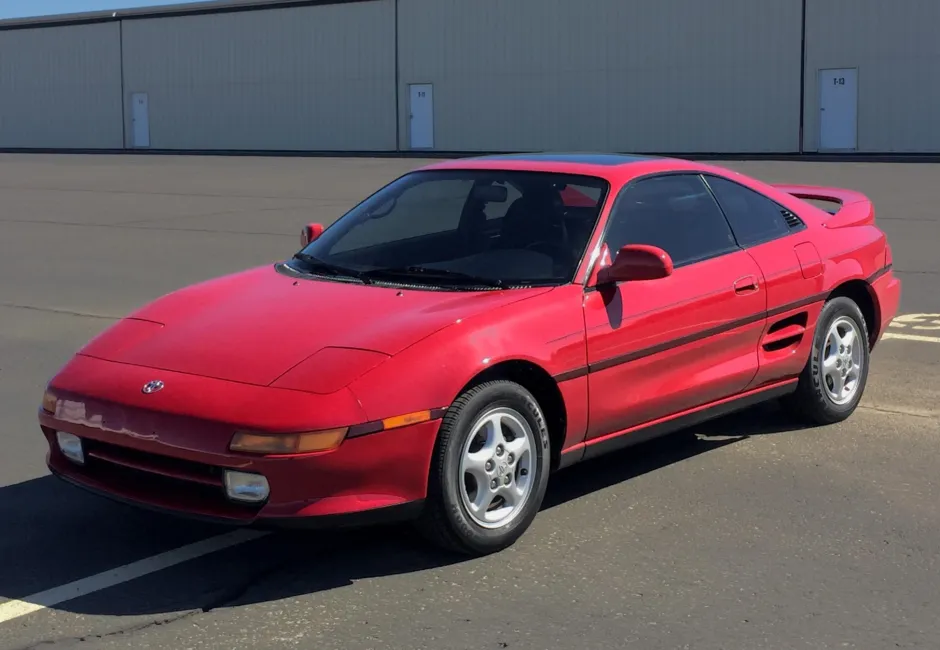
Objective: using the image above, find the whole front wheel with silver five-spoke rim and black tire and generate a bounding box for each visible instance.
[419,380,551,555]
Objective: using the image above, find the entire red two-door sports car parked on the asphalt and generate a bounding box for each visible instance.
[39,154,901,554]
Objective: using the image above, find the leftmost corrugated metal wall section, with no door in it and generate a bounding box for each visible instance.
[0,23,124,149]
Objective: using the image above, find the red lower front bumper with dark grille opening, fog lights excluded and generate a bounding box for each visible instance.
[40,414,439,527]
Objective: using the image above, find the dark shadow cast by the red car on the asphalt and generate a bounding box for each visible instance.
[0,405,816,617]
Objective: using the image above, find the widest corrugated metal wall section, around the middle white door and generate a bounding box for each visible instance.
[399,0,801,153]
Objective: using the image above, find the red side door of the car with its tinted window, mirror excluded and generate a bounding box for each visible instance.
[584,173,766,444]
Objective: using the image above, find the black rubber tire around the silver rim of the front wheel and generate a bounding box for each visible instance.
[417,380,551,556]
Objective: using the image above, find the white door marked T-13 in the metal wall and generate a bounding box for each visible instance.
[819,68,858,151]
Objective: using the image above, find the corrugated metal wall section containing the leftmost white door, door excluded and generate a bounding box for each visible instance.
[124,0,395,151]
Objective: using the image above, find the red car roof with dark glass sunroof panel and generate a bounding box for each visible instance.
[421,153,690,180]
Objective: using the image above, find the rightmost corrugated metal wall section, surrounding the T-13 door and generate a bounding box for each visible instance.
[804,0,940,153]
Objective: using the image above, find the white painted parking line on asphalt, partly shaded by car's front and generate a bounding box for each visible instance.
[0,530,270,623]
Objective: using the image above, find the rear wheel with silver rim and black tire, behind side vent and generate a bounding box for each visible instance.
[785,296,870,424]
